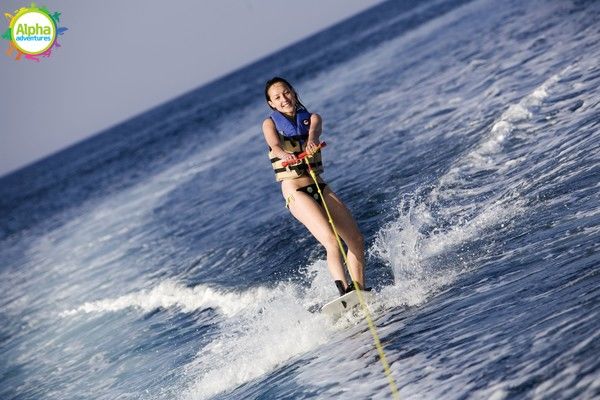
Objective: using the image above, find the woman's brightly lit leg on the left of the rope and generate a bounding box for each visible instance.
[285,191,347,285]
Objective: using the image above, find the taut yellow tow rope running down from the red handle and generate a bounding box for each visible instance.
[303,153,400,400]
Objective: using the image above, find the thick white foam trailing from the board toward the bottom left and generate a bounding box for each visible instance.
[182,261,336,399]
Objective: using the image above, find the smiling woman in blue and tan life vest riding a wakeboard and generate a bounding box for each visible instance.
[262,77,365,295]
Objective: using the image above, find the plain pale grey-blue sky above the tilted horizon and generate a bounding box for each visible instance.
[0,0,381,176]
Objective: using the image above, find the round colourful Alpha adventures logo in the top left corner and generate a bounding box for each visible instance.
[2,3,67,62]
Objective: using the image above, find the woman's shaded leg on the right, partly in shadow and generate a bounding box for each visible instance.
[323,187,365,288]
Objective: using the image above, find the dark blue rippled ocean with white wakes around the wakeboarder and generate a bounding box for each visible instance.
[0,0,600,400]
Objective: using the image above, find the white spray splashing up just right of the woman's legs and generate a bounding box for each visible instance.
[371,177,522,307]
